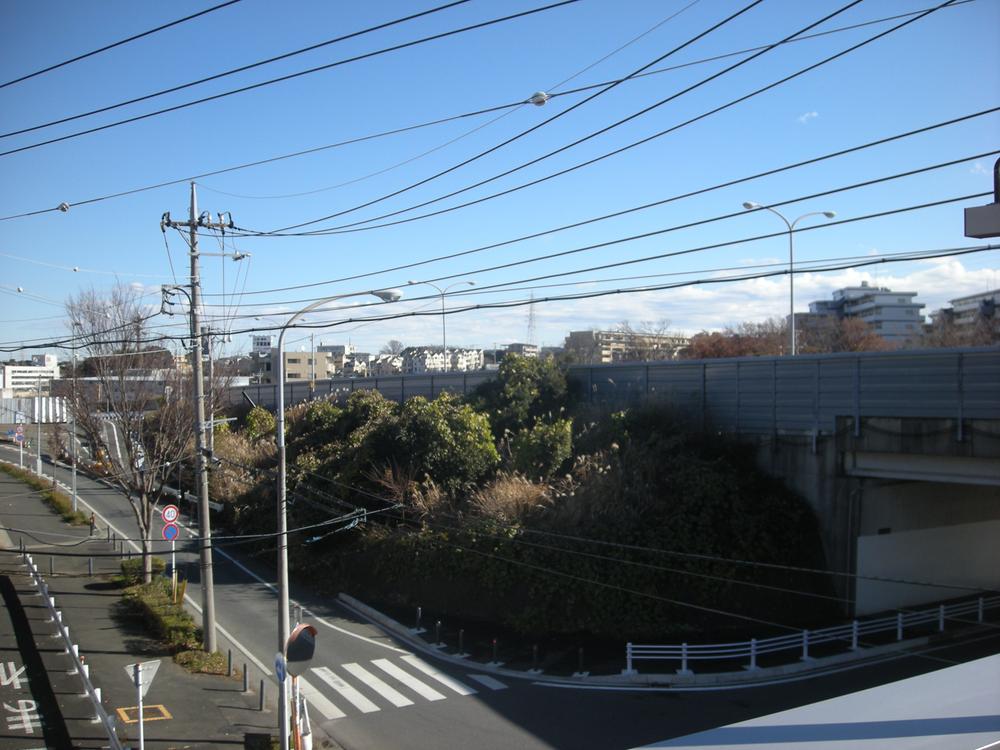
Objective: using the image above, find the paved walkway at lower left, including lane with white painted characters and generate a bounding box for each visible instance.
[0,474,275,750]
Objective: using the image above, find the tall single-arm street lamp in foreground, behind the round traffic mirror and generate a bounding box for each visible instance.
[275,289,403,750]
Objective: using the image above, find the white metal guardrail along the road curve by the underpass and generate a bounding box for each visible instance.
[622,596,1000,675]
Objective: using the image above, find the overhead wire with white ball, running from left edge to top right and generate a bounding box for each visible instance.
[0,0,977,221]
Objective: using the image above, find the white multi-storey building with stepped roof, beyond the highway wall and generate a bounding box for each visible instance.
[809,281,924,344]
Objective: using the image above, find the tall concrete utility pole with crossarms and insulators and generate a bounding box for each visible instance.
[161,182,227,653]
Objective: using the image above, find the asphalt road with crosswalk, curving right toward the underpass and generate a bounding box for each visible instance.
[3,446,1000,750]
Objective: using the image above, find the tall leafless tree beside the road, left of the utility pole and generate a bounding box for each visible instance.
[66,284,194,583]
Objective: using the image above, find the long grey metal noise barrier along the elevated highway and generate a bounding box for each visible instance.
[229,347,1000,438]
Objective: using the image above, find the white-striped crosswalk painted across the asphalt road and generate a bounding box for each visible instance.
[299,654,507,720]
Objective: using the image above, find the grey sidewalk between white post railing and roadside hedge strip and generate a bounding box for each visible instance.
[0,474,276,750]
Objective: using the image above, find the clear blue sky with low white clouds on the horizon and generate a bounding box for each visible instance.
[0,0,1000,359]
